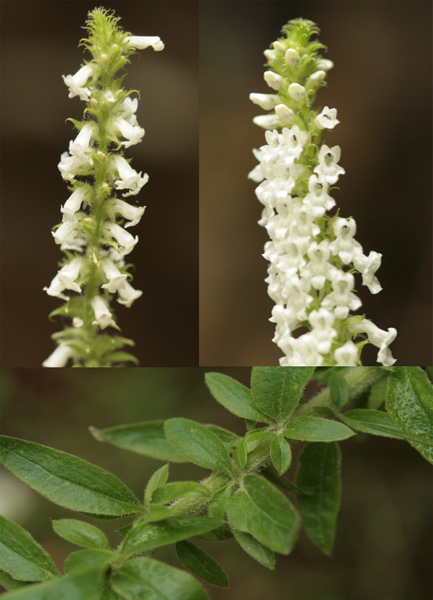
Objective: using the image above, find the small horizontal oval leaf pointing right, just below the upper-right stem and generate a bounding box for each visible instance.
[284,417,355,442]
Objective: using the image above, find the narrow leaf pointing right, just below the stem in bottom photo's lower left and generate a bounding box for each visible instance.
[122,517,223,553]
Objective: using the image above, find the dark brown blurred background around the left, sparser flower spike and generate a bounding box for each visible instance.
[1,0,198,367]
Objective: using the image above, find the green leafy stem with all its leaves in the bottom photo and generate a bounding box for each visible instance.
[0,367,433,600]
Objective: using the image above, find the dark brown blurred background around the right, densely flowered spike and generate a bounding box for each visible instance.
[200,0,433,365]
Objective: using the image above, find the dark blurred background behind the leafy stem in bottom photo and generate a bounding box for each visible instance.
[0,368,433,600]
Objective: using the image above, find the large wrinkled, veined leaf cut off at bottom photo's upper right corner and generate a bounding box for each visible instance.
[386,367,433,463]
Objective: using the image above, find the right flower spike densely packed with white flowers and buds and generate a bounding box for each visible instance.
[249,19,397,366]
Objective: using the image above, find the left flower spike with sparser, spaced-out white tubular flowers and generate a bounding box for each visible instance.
[43,8,164,367]
